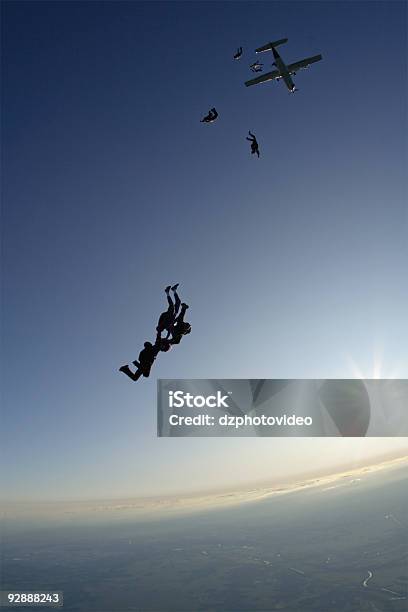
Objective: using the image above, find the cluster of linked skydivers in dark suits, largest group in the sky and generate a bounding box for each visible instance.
[119,283,191,381]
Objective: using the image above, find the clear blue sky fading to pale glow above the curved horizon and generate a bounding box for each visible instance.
[2,2,408,499]
